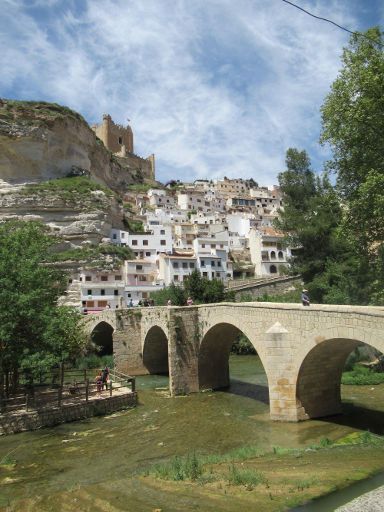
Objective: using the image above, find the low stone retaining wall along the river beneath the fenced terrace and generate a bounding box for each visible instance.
[0,392,137,435]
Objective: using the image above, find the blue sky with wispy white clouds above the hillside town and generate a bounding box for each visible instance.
[0,0,384,186]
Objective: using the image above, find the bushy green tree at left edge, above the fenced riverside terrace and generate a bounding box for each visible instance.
[0,221,85,388]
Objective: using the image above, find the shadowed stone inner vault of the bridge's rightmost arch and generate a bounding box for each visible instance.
[296,332,384,420]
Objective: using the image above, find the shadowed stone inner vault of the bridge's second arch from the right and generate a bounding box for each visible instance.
[198,322,268,389]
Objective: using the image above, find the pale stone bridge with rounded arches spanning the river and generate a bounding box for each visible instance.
[84,302,384,421]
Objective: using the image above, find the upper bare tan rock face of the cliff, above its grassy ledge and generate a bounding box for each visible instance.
[0,99,135,192]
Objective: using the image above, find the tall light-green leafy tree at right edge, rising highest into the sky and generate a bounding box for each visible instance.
[321,27,384,251]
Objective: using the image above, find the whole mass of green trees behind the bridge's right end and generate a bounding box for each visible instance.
[278,28,384,304]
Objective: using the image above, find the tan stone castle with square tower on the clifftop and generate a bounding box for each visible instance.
[92,114,155,180]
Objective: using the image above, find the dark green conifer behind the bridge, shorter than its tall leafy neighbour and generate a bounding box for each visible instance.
[276,148,366,304]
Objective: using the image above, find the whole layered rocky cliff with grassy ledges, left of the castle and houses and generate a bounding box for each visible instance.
[0,100,147,256]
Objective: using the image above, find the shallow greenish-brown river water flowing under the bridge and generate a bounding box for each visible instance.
[0,356,384,506]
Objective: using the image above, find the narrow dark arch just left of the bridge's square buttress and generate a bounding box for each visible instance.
[143,325,169,375]
